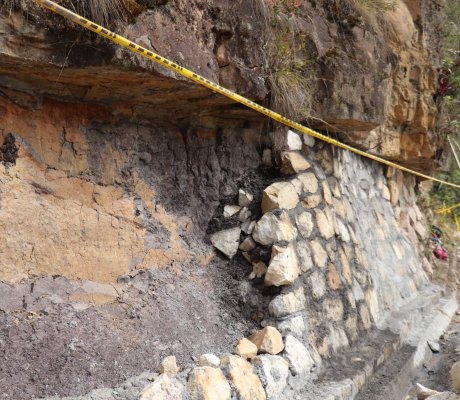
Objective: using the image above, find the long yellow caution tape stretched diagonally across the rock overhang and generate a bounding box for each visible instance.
[34,0,460,188]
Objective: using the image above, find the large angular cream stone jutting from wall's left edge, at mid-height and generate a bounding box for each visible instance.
[265,244,300,286]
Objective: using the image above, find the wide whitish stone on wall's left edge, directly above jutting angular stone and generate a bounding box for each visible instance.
[252,211,297,246]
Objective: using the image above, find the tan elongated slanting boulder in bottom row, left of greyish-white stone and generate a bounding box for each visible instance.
[221,355,267,400]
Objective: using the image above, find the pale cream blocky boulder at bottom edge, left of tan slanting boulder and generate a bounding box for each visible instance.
[188,367,231,400]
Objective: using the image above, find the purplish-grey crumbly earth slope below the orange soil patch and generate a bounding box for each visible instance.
[0,258,266,400]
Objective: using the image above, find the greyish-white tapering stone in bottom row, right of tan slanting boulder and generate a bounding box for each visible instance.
[252,355,289,400]
